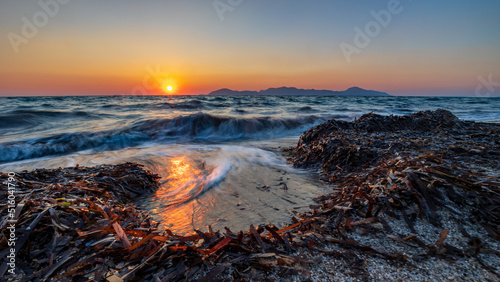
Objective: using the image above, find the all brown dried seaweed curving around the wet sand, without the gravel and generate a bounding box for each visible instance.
[0,110,500,281]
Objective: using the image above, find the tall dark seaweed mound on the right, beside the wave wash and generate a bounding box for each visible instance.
[288,110,500,276]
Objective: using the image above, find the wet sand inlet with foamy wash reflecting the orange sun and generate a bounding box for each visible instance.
[0,138,330,235]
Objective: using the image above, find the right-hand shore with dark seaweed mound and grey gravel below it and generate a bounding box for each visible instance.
[289,110,500,281]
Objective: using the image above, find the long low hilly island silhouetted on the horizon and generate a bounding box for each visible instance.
[207,87,391,97]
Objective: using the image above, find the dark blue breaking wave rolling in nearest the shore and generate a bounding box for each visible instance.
[0,113,326,162]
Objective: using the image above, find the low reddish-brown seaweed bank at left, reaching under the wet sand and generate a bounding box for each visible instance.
[0,163,328,281]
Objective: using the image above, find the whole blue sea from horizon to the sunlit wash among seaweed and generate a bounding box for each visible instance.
[0,95,500,234]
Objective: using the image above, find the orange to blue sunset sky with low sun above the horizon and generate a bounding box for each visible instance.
[0,0,500,96]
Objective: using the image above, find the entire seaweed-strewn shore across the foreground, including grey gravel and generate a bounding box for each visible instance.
[0,110,500,281]
